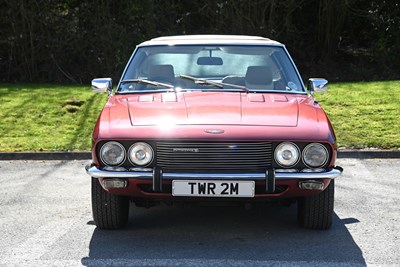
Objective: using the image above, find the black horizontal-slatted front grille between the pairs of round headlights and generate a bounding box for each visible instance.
[156,141,272,172]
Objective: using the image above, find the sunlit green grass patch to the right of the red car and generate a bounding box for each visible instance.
[316,81,400,149]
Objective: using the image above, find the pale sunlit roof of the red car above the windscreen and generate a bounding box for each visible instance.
[138,35,283,46]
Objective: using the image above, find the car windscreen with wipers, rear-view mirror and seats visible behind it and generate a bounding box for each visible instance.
[117,45,304,93]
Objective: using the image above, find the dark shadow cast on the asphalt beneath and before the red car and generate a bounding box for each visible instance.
[82,205,366,266]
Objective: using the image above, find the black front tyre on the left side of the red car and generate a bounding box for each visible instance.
[92,177,129,230]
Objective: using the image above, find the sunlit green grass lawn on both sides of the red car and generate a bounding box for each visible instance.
[0,81,400,152]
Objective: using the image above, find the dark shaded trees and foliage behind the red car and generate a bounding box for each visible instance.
[0,0,400,84]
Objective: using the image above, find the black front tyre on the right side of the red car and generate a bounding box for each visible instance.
[297,179,335,230]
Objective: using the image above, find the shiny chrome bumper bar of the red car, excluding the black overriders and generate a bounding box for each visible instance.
[86,165,343,180]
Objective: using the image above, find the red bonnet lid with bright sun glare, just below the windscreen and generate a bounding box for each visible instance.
[120,92,299,127]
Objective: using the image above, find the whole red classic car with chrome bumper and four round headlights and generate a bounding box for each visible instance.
[86,35,342,229]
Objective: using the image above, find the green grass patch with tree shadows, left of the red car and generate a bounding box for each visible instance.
[0,84,107,152]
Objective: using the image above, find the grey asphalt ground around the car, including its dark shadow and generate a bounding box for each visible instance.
[0,158,400,267]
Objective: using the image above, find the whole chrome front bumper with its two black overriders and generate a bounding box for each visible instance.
[86,164,343,192]
